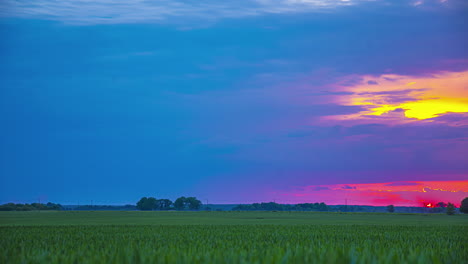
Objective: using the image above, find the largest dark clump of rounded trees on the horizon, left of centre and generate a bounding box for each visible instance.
[136,196,202,211]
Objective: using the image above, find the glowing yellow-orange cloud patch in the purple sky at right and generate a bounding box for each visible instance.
[326,71,468,123]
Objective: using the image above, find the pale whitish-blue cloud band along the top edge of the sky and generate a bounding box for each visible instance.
[0,0,458,24]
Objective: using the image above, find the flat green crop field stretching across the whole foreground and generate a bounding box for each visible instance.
[0,211,468,263]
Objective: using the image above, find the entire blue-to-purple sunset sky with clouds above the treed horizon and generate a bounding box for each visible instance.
[0,0,468,206]
